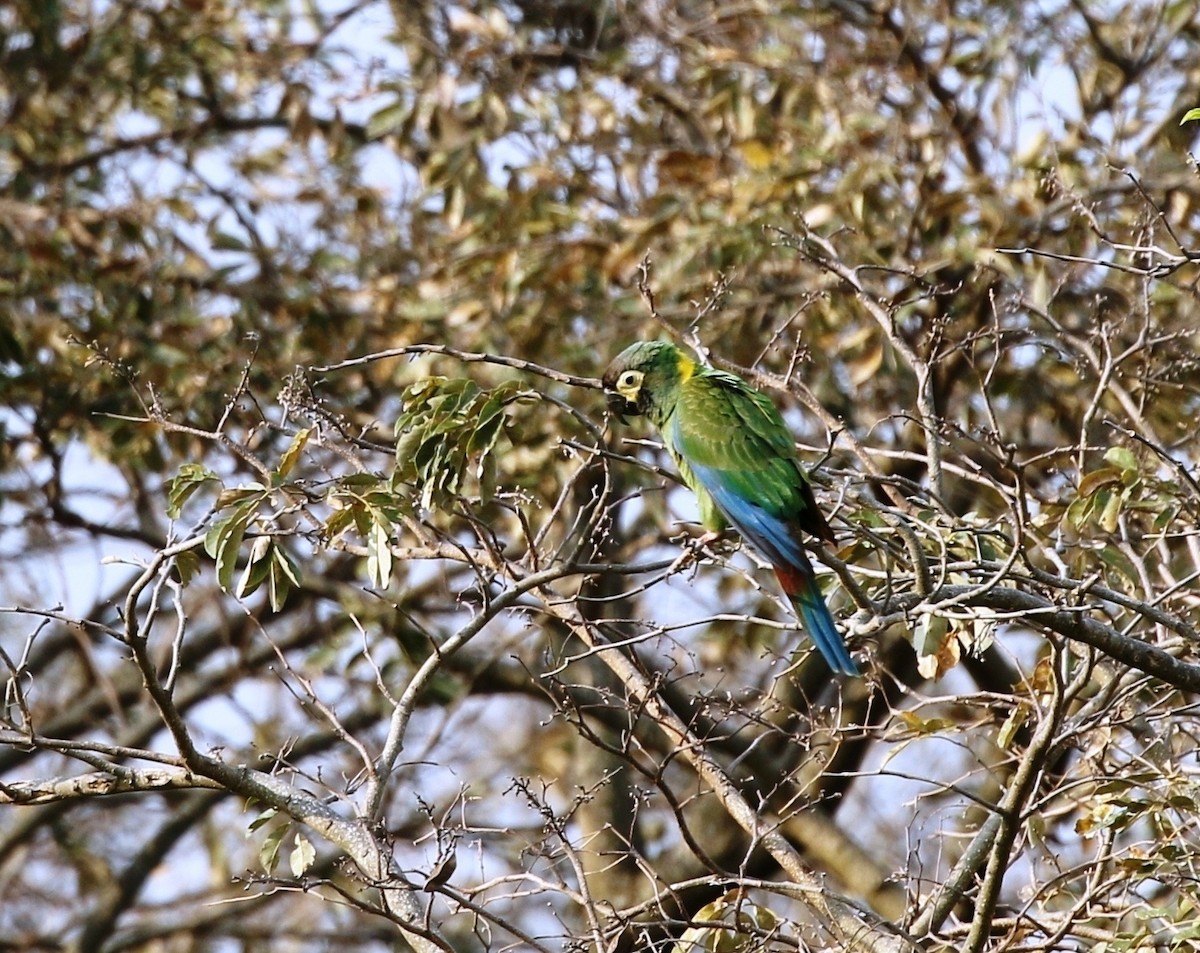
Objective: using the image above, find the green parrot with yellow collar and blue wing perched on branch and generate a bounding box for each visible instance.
[604,341,859,675]
